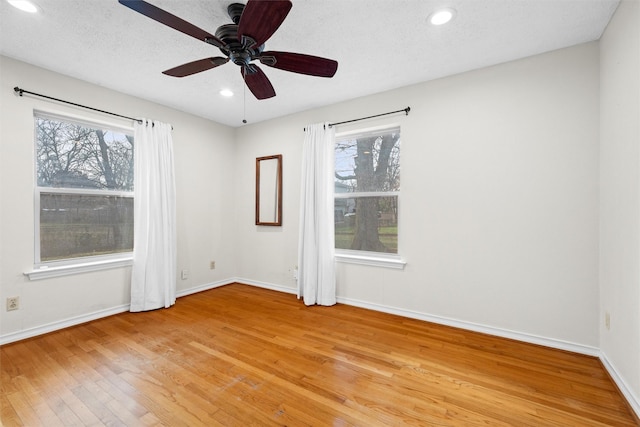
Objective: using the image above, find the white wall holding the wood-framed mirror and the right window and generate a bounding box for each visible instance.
[236,43,599,353]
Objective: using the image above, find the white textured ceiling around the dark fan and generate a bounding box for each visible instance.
[0,0,618,127]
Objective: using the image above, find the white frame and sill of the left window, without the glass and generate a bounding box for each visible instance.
[24,109,135,280]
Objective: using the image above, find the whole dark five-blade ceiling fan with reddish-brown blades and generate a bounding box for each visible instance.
[118,0,338,99]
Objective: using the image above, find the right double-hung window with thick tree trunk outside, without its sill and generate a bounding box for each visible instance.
[334,126,400,254]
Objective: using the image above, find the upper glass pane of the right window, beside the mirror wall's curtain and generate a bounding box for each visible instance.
[335,128,400,193]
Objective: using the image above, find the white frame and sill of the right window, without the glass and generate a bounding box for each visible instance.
[333,123,406,270]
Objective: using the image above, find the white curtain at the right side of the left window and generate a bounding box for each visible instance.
[130,119,176,311]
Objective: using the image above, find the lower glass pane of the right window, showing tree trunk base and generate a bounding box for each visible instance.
[334,196,398,254]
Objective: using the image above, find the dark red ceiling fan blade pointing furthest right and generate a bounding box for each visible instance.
[258,50,338,77]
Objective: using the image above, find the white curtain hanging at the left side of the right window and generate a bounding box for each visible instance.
[298,123,336,305]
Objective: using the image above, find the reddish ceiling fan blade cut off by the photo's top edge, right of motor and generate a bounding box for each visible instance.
[238,0,293,47]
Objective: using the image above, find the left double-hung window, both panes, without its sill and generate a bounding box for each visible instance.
[35,112,133,266]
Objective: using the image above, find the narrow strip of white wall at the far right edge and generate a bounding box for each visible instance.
[599,0,640,414]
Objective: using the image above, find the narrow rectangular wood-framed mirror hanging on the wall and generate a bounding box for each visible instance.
[256,154,282,226]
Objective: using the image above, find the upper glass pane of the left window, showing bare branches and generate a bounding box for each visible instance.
[35,117,133,191]
